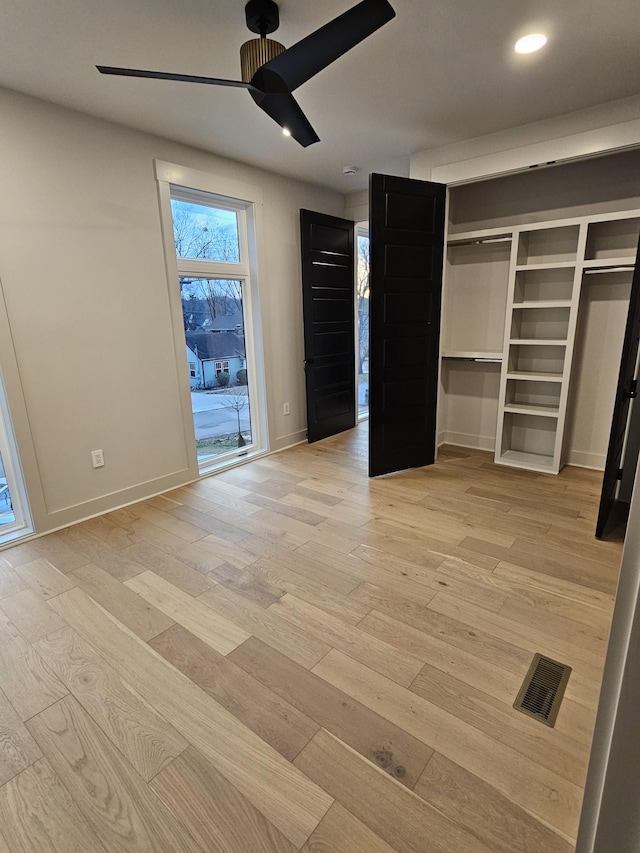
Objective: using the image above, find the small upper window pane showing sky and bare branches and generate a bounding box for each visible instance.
[171,198,240,263]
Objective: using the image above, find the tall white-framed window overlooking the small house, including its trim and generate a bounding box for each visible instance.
[156,162,267,473]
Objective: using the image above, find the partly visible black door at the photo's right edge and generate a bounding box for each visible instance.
[596,233,640,539]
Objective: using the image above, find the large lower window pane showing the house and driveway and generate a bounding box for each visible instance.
[180,276,253,461]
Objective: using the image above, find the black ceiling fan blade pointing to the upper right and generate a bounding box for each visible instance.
[260,0,396,92]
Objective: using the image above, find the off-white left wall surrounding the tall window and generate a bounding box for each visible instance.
[0,90,344,532]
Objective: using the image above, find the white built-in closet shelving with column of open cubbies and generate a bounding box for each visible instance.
[441,211,640,473]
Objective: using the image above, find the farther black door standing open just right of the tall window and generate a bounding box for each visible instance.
[300,210,356,441]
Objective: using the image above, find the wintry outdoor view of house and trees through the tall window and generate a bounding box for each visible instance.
[171,198,252,462]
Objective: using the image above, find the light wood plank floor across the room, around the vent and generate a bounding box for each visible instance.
[0,428,621,853]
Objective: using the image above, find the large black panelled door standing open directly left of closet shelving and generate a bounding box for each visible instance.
[369,174,446,477]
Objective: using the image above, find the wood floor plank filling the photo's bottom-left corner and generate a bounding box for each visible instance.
[0,758,108,853]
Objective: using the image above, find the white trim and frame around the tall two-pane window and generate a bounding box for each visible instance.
[154,160,269,474]
